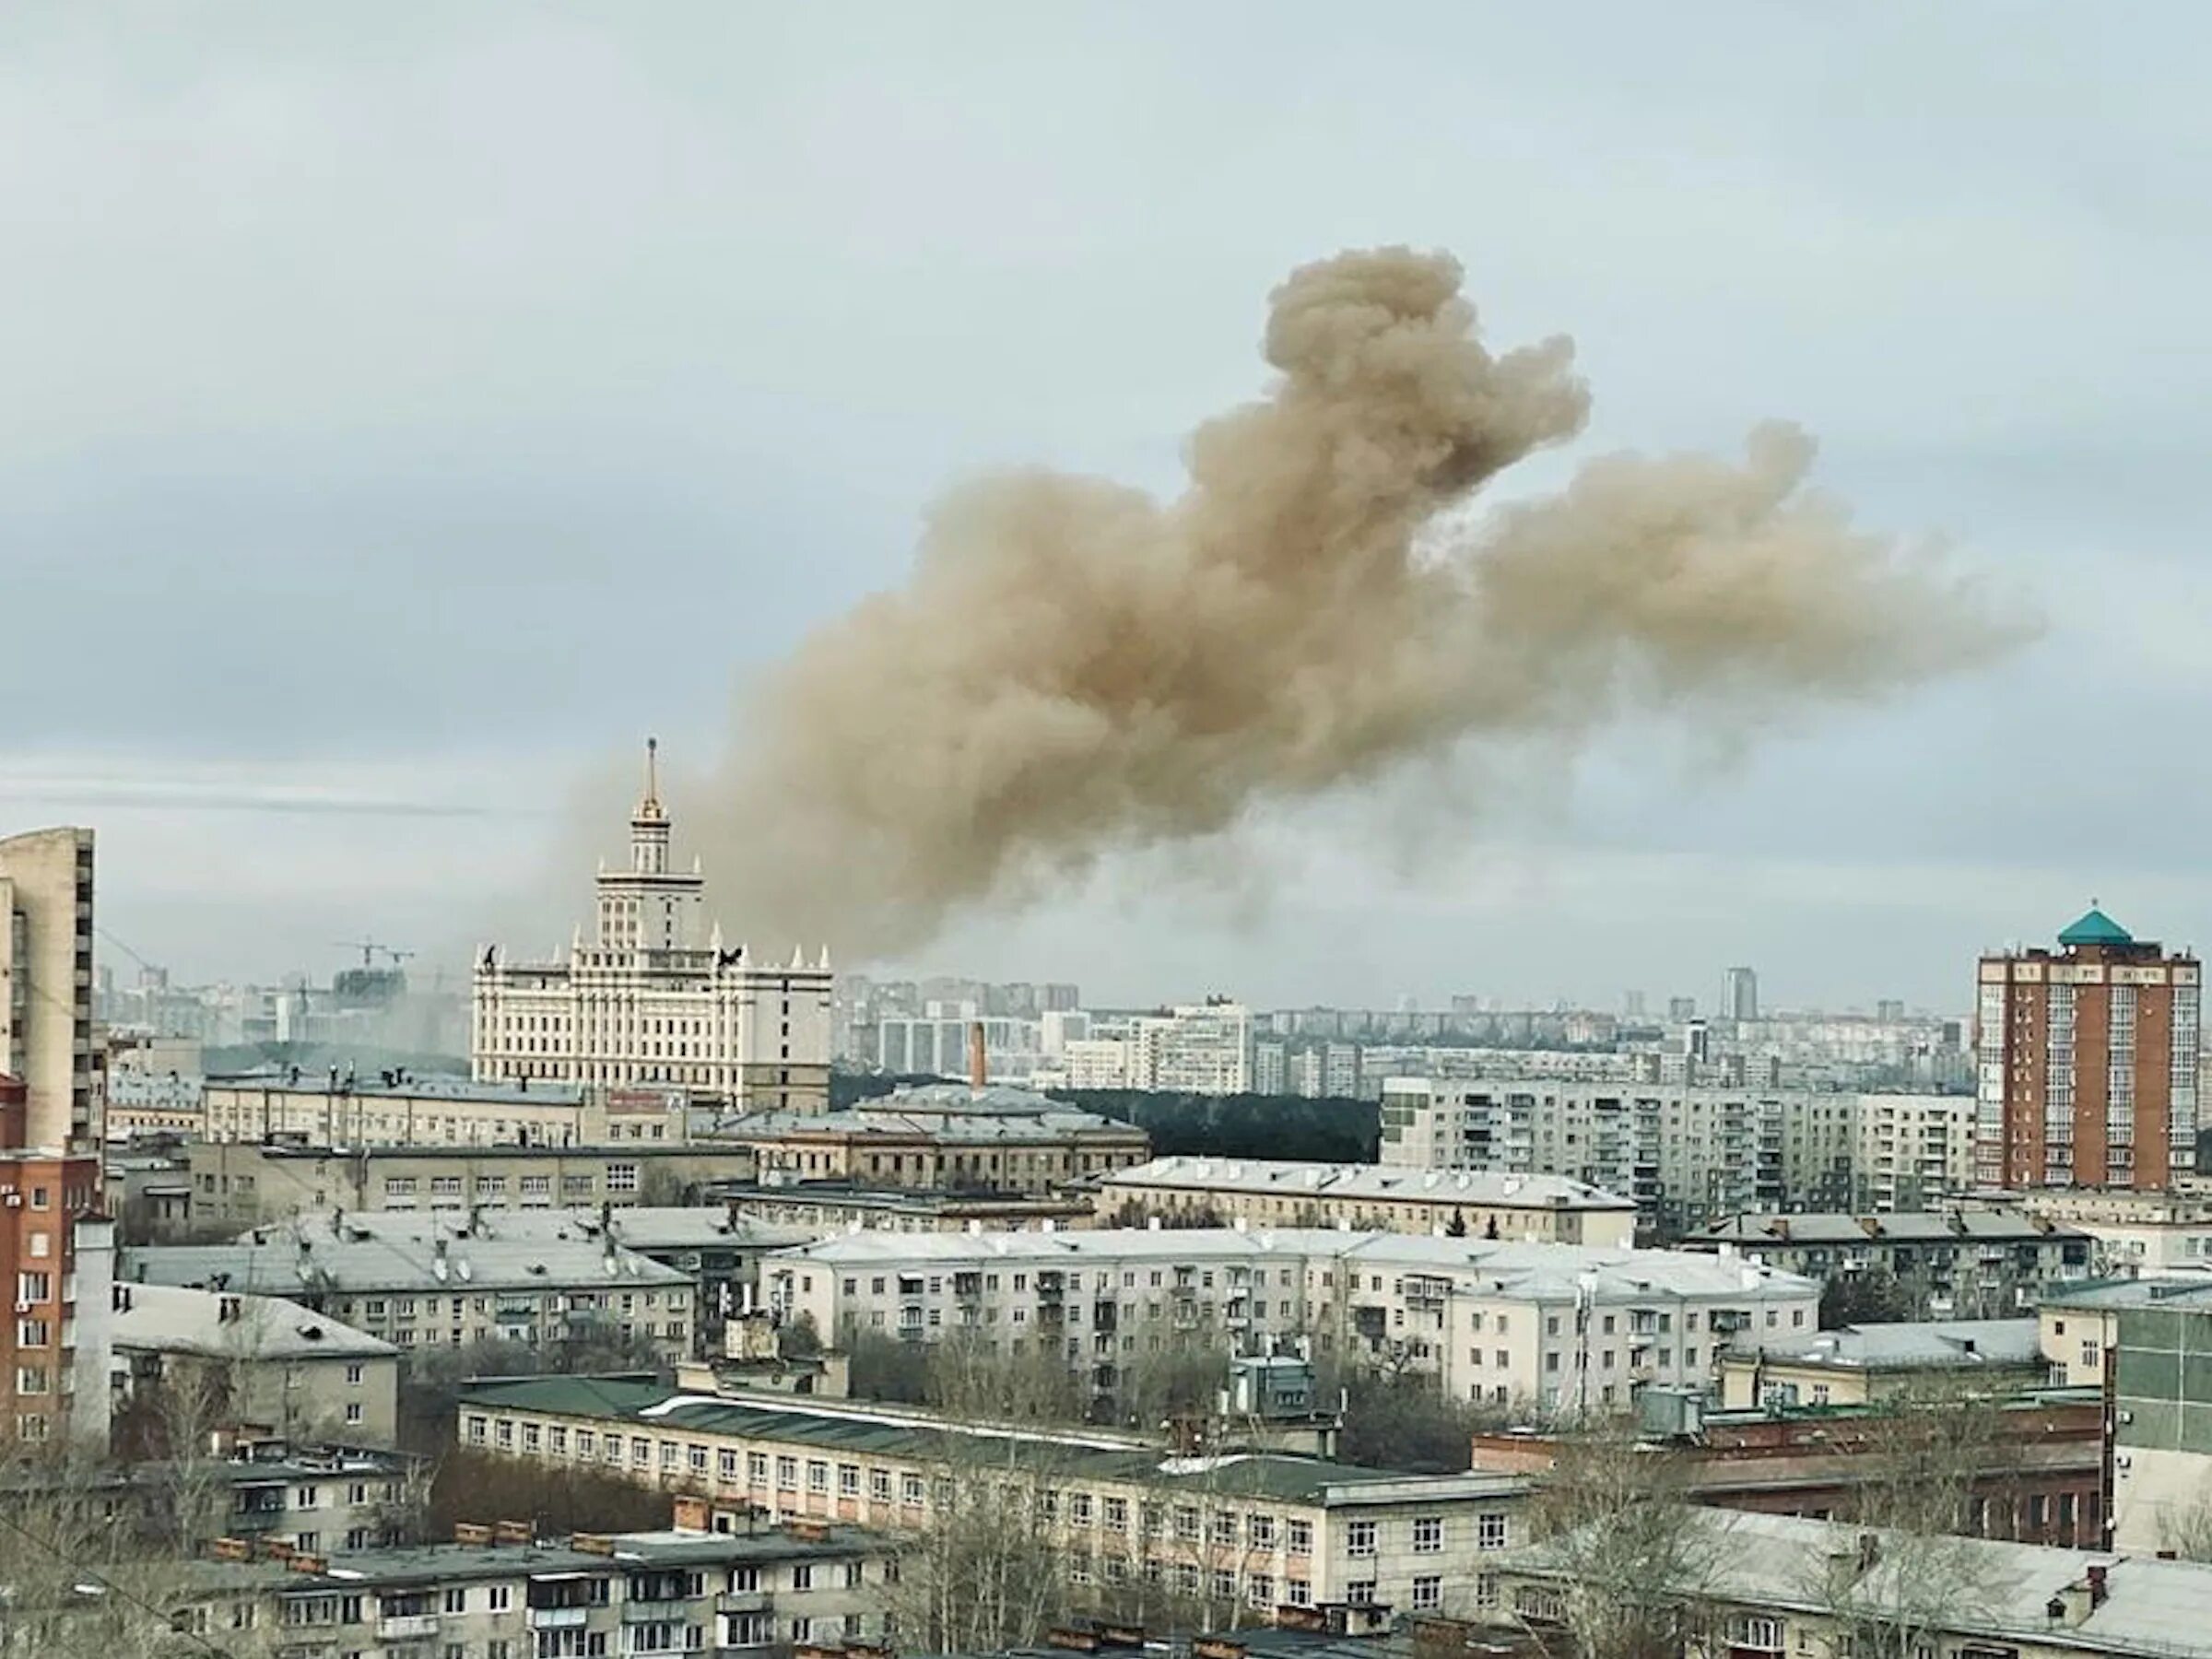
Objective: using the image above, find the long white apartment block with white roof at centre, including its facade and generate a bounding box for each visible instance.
[763,1228,1820,1414]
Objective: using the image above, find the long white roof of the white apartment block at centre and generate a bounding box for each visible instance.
[776,1228,1820,1300]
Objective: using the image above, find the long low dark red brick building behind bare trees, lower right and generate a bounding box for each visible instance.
[1473,1389,2103,1548]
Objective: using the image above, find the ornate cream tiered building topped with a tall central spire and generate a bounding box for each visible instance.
[471,743,831,1111]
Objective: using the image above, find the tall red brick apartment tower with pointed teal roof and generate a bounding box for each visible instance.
[1973,909,2201,1190]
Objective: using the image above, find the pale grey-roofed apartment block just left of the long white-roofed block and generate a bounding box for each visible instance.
[122,1228,697,1360]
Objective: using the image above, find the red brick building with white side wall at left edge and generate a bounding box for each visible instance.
[0,1073,111,1460]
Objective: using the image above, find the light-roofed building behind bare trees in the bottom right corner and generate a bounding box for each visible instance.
[1495,1509,2212,1659]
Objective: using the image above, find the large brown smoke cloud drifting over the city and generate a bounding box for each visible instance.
[686,248,2019,960]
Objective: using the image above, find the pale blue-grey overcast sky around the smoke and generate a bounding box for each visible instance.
[0,0,2212,1006]
